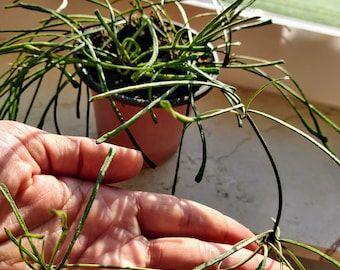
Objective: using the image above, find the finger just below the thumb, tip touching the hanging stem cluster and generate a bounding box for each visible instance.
[137,192,256,249]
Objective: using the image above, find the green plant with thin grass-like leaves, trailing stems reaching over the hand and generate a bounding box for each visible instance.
[0,0,340,269]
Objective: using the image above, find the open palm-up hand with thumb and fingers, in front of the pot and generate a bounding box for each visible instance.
[0,121,280,269]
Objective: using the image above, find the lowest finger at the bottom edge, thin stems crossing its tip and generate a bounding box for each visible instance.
[146,238,286,270]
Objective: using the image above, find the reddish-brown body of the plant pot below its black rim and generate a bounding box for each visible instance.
[93,95,187,167]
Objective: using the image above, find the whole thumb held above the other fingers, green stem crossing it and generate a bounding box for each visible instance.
[5,121,143,182]
